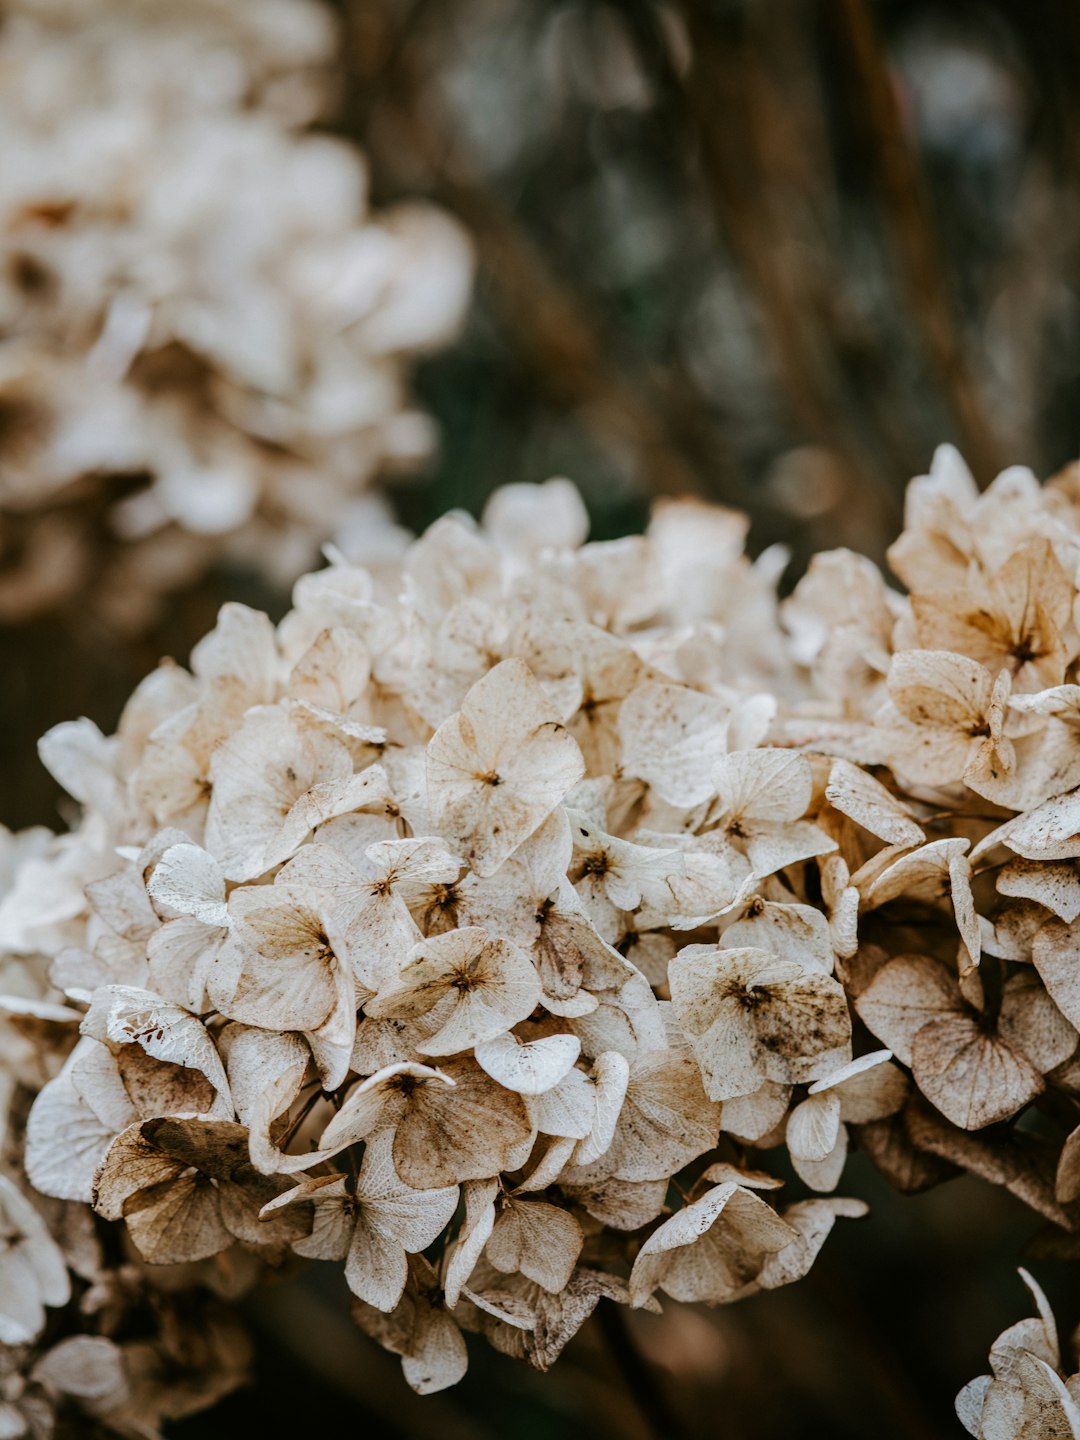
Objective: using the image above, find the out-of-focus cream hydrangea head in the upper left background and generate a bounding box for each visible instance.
[0,0,471,625]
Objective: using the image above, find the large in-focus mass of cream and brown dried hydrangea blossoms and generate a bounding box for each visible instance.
[0,449,1080,1440]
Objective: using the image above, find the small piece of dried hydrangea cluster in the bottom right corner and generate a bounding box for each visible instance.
[956,1270,1080,1440]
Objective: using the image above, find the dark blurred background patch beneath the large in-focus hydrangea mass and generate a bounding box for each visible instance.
[176,1151,1080,1440]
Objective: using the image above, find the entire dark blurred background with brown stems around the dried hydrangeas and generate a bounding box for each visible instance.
[0,0,1080,1440]
